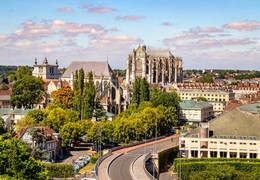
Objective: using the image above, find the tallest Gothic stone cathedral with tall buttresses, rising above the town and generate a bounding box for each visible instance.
[126,46,183,85]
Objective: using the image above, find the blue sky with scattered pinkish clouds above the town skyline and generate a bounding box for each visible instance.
[0,0,260,70]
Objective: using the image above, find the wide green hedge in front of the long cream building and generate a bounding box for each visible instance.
[174,158,260,180]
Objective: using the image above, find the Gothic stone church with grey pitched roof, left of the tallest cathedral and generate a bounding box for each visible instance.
[61,61,126,114]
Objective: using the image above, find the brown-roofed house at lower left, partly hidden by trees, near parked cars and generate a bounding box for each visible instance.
[19,126,63,161]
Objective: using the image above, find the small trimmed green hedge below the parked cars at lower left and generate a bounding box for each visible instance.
[44,164,75,178]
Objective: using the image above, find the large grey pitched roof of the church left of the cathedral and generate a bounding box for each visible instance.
[62,61,113,78]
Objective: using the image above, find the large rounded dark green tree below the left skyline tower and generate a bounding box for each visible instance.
[11,75,45,109]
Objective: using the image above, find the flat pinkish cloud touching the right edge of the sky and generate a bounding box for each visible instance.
[223,21,260,31]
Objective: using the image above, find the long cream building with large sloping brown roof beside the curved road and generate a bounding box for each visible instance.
[180,103,260,158]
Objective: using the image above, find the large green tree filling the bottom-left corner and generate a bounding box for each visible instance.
[0,137,47,179]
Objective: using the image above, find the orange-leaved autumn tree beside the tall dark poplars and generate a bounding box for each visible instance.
[51,88,74,109]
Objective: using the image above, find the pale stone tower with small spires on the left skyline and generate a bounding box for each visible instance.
[32,57,61,79]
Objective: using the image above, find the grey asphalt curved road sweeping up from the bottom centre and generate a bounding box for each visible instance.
[108,137,178,180]
